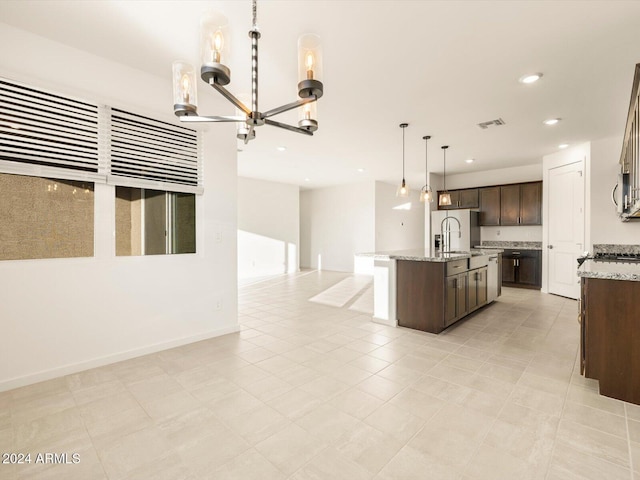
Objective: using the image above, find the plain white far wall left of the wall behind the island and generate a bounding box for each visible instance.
[300,182,375,272]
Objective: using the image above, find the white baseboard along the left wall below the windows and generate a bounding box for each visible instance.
[0,324,240,392]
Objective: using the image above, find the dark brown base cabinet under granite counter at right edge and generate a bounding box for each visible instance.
[580,278,640,404]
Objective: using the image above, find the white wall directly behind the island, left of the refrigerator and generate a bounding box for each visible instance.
[375,182,425,252]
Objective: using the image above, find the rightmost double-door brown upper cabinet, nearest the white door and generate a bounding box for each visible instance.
[500,182,542,225]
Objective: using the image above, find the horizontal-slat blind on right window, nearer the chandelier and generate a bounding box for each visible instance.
[109,108,202,193]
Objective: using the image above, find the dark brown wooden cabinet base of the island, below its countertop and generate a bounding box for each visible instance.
[396,259,487,333]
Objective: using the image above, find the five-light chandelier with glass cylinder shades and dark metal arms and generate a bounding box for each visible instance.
[173,0,323,144]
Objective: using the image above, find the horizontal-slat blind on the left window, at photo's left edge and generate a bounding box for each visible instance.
[0,79,104,181]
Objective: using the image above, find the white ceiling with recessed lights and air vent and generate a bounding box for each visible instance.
[0,0,640,189]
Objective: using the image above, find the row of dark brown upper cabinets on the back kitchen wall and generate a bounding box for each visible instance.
[438,182,542,226]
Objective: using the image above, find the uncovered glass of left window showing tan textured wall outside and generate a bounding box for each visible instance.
[0,173,94,260]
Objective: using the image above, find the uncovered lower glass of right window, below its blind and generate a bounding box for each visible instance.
[116,187,196,256]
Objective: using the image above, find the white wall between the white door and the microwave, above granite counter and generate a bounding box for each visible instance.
[589,136,640,247]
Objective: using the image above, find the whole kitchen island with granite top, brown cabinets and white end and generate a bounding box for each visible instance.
[362,249,501,333]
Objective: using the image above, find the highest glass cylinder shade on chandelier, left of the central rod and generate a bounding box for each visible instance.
[200,12,231,85]
